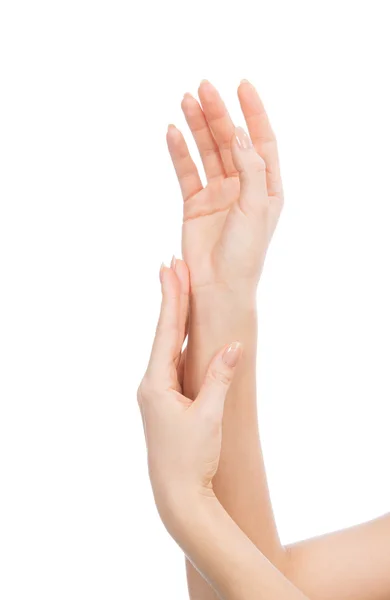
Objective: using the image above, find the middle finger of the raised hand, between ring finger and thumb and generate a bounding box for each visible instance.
[198,80,237,177]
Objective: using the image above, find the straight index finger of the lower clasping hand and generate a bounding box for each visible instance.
[148,265,183,384]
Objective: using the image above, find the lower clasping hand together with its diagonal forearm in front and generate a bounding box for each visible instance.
[138,268,305,600]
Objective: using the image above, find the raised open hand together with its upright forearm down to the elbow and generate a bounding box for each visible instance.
[167,82,285,600]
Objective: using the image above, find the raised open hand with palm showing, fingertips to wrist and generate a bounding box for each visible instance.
[167,81,283,292]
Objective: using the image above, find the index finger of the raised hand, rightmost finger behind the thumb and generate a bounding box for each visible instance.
[238,79,283,199]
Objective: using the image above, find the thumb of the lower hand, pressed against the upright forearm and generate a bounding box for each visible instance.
[195,342,242,423]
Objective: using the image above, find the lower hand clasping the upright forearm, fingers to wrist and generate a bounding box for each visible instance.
[138,260,241,525]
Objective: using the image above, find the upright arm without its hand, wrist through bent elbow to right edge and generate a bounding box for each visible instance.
[185,290,390,600]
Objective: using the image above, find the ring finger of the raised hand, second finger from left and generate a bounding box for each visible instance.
[181,94,225,181]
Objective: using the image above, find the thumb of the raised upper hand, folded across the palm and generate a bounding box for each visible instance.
[231,127,268,214]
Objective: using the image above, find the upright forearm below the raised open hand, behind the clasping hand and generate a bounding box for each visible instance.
[185,287,286,600]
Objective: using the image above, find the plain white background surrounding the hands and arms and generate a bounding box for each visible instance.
[0,0,390,600]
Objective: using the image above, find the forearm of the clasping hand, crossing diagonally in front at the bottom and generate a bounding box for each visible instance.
[171,497,305,600]
